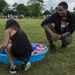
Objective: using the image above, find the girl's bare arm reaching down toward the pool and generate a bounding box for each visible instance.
[0,30,10,51]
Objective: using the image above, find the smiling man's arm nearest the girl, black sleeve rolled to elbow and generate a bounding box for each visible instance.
[41,13,61,41]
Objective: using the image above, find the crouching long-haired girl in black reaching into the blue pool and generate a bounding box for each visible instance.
[0,19,33,73]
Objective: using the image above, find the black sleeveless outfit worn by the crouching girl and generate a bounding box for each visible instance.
[10,32,33,58]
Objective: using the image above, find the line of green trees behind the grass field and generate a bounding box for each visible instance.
[0,0,75,17]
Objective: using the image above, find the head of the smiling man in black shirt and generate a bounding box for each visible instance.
[57,2,68,17]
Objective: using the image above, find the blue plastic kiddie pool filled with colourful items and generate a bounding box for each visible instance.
[0,43,48,65]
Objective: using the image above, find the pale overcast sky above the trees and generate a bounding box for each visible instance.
[5,0,75,11]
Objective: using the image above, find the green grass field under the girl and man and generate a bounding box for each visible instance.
[0,19,75,75]
